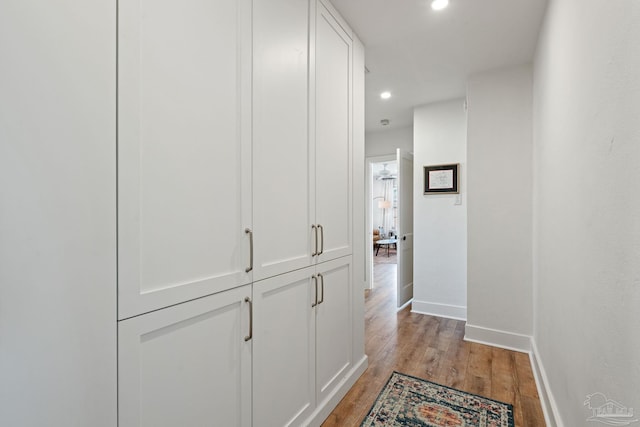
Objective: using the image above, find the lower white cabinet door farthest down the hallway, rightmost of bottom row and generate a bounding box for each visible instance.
[316,257,353,404]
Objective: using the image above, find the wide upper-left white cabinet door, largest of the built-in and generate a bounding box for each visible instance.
[118,0,251,319]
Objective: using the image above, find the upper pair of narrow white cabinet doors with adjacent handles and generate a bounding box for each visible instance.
[253,0,353,280]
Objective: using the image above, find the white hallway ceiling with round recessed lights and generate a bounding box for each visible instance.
[332,0,547,132]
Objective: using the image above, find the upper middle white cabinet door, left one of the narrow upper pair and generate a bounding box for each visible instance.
[253,0,312,280]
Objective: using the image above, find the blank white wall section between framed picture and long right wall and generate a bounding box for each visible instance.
[465,65,533,351]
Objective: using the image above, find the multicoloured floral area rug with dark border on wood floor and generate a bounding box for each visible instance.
[361,372,513,427]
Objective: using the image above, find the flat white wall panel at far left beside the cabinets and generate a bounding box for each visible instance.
[0,0,117,427]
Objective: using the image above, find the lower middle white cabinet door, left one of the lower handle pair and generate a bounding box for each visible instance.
[253,267,316,427]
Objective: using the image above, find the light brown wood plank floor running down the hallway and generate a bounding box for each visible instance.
[323,260,545,427]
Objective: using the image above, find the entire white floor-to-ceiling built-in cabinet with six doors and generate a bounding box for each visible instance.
[118,0,366,427]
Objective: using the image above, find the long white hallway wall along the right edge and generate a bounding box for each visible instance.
[534,0,640,426]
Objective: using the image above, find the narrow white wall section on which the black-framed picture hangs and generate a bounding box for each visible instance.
[412,99,467,319]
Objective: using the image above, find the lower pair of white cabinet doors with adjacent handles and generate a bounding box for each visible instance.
[253,256,352,426]
